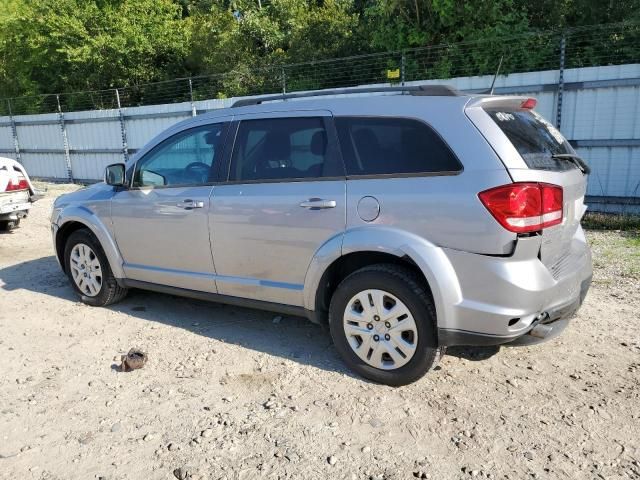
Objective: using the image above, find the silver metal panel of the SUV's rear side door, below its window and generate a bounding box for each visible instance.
[210,180,345,306]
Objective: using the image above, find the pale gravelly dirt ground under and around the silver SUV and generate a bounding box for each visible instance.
[0,186,640,480]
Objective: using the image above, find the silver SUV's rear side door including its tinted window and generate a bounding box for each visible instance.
[210,112,345,306]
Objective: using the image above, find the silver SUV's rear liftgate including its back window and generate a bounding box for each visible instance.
[467,97,587,272]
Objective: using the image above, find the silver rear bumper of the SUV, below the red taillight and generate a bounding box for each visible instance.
[438,229,592,346]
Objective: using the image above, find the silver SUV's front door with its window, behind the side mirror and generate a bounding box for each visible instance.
[111,123,227,293]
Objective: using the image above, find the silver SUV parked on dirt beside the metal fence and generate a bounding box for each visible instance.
[51,86,591,385]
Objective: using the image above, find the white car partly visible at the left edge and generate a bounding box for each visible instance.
[0,157,43,230]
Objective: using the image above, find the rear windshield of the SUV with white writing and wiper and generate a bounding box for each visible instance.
[486,110,577,171]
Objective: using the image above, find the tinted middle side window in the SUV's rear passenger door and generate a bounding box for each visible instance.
[229,117,338,182]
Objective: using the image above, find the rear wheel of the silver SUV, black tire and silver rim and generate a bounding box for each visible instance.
[329,264,444,387]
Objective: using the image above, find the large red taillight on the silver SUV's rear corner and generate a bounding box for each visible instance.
[478,182,562,233]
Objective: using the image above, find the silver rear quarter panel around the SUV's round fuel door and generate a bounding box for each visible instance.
[347,169,516,255]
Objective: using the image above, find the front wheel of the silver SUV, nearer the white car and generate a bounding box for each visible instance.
[64,229,127,307]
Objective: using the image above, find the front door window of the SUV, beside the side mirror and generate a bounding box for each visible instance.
[133,123,225,187]
